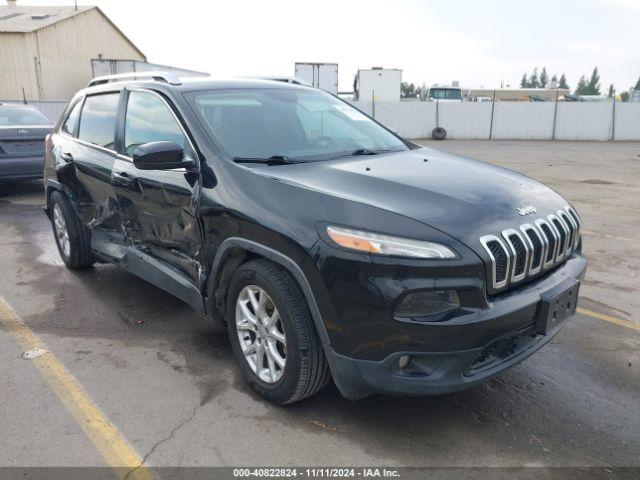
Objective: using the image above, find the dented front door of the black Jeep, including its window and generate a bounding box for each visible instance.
[112,90,205,296]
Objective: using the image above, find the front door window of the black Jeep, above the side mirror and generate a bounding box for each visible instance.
[124,91,188,156]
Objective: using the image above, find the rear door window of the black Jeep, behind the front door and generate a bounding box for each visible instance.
[78,93,120,150]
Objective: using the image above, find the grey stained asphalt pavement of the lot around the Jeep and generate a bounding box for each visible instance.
[0,141,640,472]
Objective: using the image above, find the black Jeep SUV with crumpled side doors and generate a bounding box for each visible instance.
[44,73,587,404]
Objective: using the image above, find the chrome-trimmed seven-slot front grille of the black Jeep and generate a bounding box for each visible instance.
[480,207,581,289]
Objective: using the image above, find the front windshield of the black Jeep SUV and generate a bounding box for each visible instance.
[187,88,409,161]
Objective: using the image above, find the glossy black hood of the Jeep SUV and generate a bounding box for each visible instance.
[260,148,568,246]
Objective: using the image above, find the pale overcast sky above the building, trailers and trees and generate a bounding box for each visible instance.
[8,0,640,93]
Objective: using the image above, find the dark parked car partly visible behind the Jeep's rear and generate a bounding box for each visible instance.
[0,103,53,183]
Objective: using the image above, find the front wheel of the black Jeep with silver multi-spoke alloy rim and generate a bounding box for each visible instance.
[227,259,330,405]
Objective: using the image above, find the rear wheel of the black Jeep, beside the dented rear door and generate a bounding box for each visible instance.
[49,191,95,270]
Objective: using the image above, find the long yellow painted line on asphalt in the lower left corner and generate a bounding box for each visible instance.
[0,297,153,480]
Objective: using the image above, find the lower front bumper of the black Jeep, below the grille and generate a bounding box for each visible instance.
[325,254,587,400]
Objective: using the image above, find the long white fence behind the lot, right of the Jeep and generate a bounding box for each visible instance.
[352,101,640,140]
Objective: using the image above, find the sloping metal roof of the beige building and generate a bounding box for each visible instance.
[0,5,96,33]
